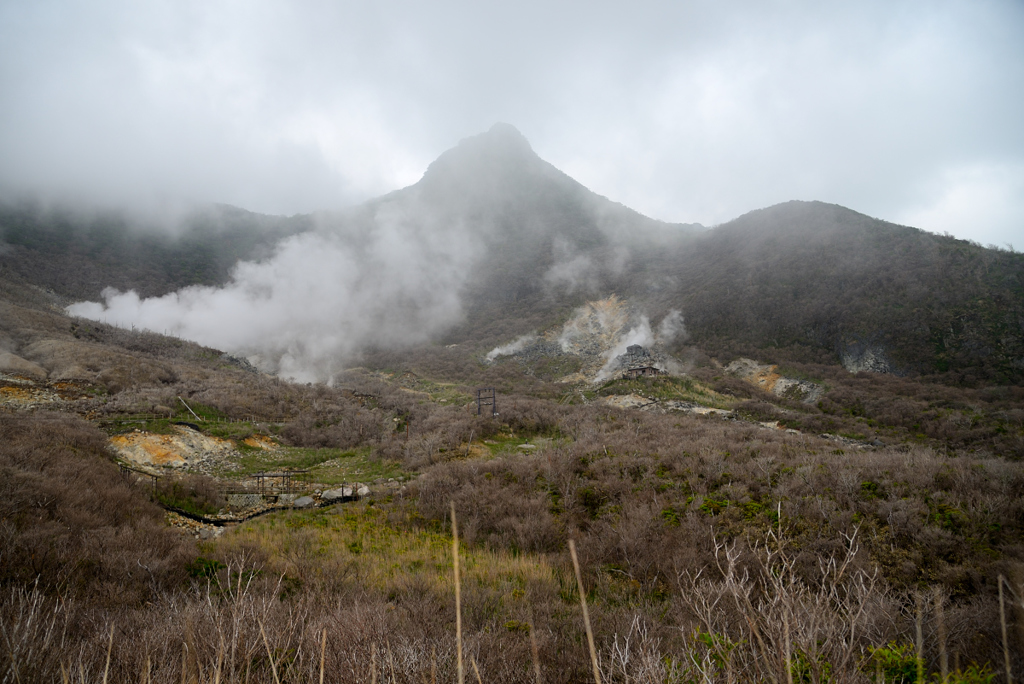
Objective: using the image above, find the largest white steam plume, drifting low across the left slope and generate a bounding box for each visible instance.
[68,205,479,381]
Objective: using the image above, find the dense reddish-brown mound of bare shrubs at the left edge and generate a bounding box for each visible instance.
[0,413,190,604]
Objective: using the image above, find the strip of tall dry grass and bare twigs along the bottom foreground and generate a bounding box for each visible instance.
[0,535,1024,684]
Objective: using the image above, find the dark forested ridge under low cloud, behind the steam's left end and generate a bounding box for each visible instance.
[0,204,312,300]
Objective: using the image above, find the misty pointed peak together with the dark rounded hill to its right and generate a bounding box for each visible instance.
[352,125,1024,383]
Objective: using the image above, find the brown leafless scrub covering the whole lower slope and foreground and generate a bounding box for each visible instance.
[0,276,1024,684]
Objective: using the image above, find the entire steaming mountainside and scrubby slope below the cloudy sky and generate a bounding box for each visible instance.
[0,126,1024,684]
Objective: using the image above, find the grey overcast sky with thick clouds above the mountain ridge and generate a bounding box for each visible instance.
[0,0,1024,245]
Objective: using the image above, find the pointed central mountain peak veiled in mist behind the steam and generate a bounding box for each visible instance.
[325,124,705,341]
